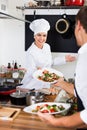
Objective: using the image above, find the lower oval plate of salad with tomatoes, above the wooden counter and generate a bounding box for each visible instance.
[23,102,71,114]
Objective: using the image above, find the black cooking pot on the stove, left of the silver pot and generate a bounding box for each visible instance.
[10,92,26,105]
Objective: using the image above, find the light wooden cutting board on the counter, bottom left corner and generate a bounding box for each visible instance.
[0,107,21,121]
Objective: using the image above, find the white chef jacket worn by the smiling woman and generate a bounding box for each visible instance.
[21,43,66,89]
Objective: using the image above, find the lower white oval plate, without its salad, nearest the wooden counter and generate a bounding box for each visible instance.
[23,102,71,114]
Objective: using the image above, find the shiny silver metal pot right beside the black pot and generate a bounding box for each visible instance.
[26,91,44,105]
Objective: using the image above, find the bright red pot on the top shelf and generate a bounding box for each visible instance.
[64,0,84,6]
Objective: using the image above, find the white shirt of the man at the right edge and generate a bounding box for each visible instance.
[75,43,87,124]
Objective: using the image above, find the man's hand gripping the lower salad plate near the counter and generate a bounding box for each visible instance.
[37,112,56,126]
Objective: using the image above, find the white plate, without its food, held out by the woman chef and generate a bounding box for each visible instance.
[33,68,63,83]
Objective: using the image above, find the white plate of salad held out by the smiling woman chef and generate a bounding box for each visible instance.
[33,68,63,83]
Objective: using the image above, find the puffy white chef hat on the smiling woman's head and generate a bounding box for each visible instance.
[29,18,50,35]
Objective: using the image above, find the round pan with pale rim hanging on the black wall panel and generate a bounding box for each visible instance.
[55,14,70,34]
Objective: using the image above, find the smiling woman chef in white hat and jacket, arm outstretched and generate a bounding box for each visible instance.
[17,18,75,89]
